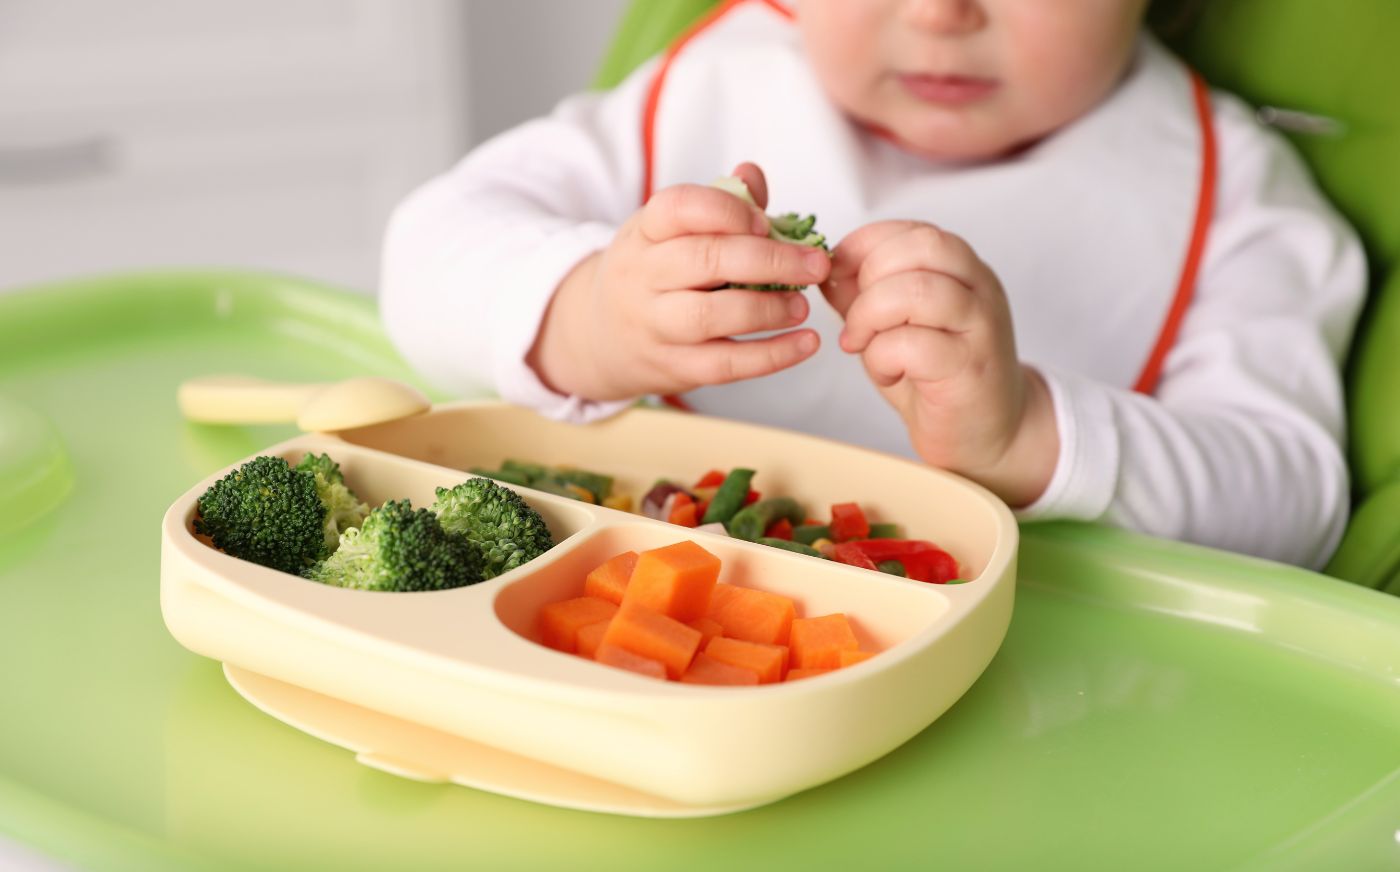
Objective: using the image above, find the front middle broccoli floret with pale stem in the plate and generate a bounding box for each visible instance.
[305,500,484,591]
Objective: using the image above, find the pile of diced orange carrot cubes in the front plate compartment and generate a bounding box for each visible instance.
[538,540,874,686]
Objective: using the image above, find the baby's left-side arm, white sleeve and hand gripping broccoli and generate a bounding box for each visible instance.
[381,69,829,420]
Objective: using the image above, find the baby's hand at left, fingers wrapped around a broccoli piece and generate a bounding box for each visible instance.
[528,164,830,400]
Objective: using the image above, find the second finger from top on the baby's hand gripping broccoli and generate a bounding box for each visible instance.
[647,233,832,290]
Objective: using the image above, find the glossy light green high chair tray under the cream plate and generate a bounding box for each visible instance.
[0,273,1400,872]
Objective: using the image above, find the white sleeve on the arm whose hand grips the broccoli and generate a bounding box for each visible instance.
[379,64,652,421]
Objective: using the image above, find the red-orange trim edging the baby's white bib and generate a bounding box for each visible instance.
[641,0,1218,412]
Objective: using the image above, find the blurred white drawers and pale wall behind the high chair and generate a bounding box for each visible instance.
[0,0,626,293]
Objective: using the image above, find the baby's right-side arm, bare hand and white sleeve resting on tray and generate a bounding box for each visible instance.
[823,116,1365,567]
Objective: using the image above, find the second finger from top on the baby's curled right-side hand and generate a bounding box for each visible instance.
[841,270,977,354]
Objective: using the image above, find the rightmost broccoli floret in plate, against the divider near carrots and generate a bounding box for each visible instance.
[433,479,554,578]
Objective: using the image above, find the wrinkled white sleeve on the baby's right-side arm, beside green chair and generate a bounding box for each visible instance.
[1021,98,1366,567]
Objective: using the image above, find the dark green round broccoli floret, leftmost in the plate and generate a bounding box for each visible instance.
[195,456,329,572]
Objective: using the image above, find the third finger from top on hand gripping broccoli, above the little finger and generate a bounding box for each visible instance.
[652,290,808,344]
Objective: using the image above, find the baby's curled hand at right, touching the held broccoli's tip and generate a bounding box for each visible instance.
[822,221,1058,505]
